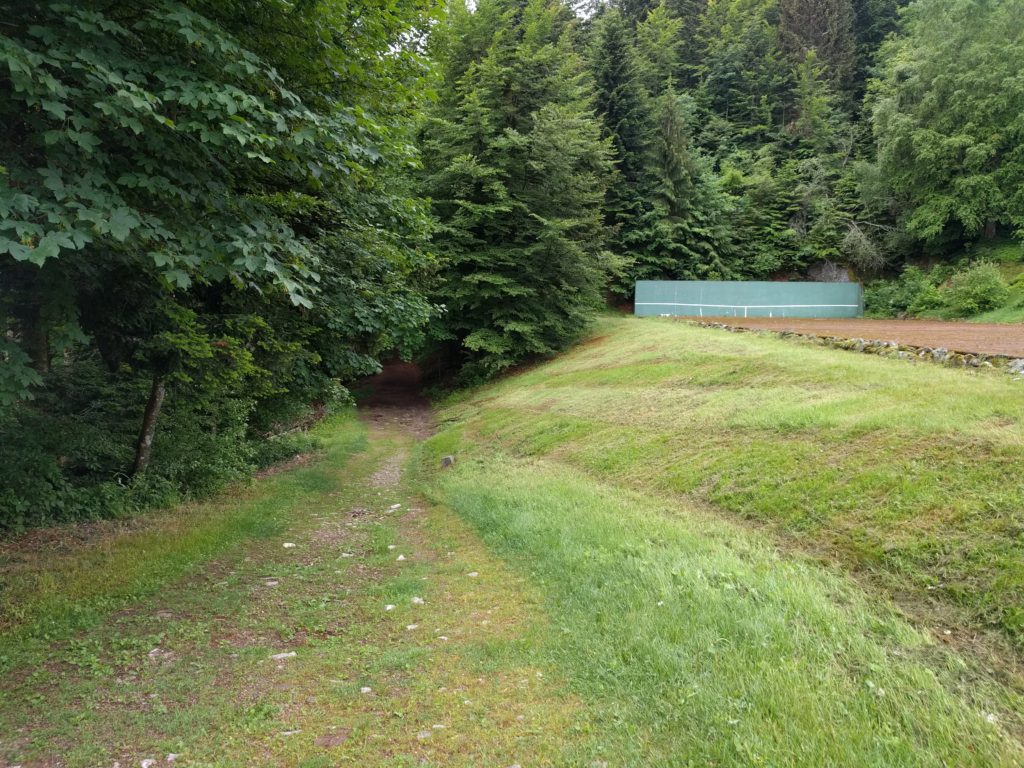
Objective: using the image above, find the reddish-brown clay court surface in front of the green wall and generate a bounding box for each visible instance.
[701,317,1024,357]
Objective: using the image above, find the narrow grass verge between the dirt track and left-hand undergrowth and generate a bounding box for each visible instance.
[0,412,366,659]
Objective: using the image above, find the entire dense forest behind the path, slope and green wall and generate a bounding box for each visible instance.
[0,0,1024,529]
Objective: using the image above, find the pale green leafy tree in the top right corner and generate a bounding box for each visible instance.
[869,0,1024,241]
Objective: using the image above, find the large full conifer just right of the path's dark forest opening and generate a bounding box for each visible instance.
[423,0,610,377]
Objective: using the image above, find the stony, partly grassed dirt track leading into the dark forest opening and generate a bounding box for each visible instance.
[0,370,578,768]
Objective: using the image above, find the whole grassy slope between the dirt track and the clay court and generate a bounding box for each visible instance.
[419,318,1024,766]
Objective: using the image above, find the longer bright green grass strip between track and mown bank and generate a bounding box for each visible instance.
[425,456,1024,766]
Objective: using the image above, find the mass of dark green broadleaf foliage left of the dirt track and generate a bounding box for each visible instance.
[0,0,436,526]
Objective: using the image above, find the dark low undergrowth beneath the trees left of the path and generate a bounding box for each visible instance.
[0,358,326,534]
